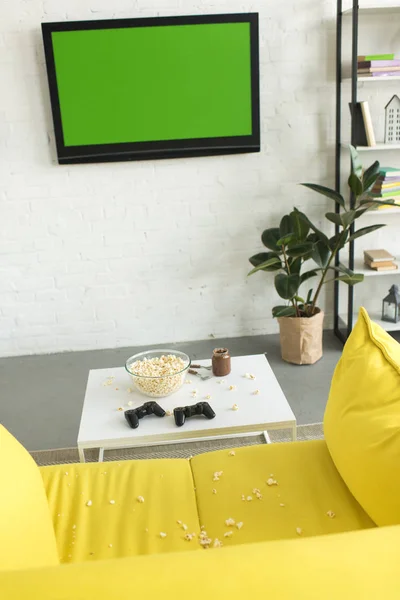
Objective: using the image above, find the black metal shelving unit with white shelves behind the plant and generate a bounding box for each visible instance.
[334,0,400,342]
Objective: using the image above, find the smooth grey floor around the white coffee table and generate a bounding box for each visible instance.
[0,331,342,450]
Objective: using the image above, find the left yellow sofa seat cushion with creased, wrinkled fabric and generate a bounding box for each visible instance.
[41,460,199,562]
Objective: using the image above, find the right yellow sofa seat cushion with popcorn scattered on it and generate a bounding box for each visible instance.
[191,440,374,545]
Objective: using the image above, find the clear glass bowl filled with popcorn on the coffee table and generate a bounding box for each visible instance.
[125,350,190,398]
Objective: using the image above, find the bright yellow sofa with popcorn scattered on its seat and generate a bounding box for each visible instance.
[0,311,400,600]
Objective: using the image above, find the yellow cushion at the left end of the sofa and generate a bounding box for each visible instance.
[0,425,58,568]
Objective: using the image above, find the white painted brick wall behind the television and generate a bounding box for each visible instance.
[0,0,336,356]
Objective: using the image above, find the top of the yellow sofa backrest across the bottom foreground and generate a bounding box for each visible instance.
[0,527,400,600]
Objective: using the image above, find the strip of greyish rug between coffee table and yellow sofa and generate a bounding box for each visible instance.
[31,423,324,466]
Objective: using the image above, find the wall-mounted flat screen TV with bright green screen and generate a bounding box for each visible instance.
[42,13,260,163]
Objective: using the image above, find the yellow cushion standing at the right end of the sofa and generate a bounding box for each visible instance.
[324,308,400,525]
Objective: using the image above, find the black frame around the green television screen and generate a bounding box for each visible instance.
[42,13,260,164]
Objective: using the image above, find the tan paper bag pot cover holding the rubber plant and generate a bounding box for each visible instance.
[278,309,324,365]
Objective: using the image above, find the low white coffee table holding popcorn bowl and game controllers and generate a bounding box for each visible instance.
[78,354,296,462]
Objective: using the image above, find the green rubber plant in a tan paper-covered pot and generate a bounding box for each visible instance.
[249,146,388,364]
